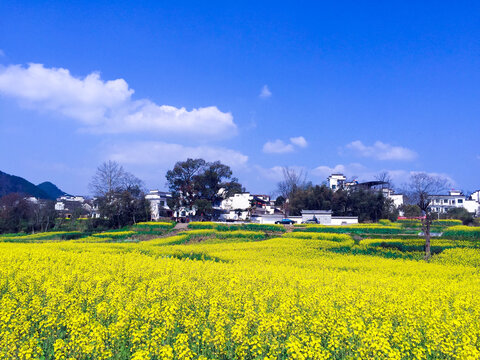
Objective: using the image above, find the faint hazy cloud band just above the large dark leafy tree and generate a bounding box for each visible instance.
[105,141,248,169]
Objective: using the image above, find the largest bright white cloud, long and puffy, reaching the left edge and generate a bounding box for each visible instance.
[0,64,237,138]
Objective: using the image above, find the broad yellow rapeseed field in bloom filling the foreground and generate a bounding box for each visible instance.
[0,235,480,359]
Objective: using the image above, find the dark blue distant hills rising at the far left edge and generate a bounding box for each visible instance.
[0,171,65,200]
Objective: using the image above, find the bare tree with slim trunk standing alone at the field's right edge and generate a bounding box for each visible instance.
[406,173,449,260]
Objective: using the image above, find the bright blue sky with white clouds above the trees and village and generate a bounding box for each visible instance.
[0,1,480,194]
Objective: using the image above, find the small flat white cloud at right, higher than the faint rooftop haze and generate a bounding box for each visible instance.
[346,140,417,161]
